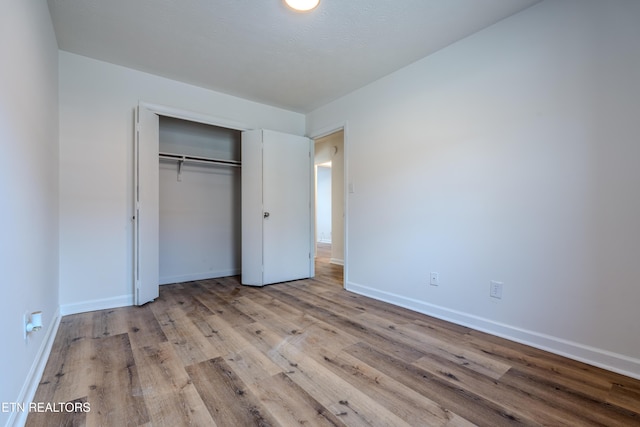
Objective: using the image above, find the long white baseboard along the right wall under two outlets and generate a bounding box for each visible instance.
[345,282,640,379]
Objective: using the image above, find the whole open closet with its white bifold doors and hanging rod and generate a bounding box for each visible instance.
[132,103,314,305]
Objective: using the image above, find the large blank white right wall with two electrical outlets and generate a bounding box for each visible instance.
[307,0,640,377]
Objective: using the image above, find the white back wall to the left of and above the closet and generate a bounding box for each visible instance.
[60,52,305,313]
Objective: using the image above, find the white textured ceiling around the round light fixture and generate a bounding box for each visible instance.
[48,0,539,113]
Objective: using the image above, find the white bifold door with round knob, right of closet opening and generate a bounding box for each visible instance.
[241,130,314,286]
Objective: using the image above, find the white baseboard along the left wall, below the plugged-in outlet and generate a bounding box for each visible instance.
[6,309,62,427]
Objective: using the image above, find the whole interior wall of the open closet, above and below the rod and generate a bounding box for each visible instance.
[159,116,241,285]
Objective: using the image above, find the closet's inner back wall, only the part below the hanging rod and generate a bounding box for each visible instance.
[159,161,241,285]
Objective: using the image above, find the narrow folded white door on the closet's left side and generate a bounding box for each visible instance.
[133,105,160,305]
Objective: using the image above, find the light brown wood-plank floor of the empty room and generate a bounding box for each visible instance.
[27,246,640,427]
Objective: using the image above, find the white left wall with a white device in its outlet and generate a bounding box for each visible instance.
[0,0,58,425]
